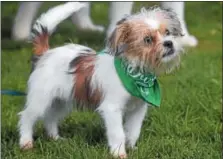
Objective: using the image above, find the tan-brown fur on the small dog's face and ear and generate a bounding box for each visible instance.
[111,20,165,67]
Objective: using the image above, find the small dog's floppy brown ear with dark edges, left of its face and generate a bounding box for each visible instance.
[108,17,130,56]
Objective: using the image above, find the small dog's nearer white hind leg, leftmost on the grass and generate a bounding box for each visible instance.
[18,85,54,150]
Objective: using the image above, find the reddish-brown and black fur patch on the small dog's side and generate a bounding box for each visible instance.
[70,54,102,108]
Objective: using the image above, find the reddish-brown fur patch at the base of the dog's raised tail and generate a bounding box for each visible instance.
[33,32,49,56]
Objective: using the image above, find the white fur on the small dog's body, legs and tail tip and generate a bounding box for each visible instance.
[19,2,183,158]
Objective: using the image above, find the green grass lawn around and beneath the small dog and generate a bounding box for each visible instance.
[1,2,222,159]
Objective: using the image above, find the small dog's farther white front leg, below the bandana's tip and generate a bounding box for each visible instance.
[124,104,147,148]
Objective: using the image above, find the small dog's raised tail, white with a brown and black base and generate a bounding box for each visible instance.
[31,2,85,56]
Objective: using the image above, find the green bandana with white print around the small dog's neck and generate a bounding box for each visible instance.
[98,51,161,107]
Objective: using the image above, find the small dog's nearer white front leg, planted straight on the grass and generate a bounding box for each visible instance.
[98,103,127,158]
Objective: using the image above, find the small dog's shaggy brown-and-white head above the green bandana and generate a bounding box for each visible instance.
[108,7,183,73]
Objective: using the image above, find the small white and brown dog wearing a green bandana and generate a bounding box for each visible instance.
[19,2,182,158]
